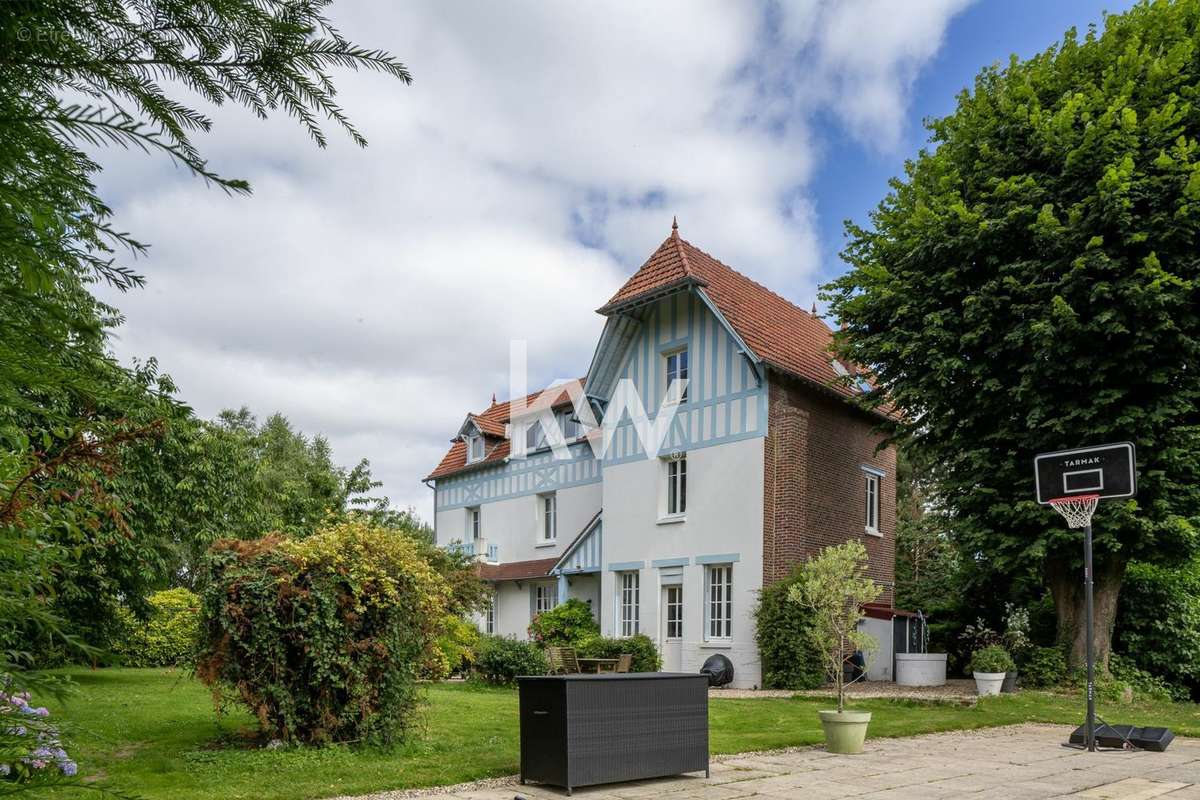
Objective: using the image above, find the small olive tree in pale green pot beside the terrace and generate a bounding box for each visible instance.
[788,540,882,753]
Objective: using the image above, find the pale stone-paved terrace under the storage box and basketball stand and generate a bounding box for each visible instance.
[340,724,1200,800]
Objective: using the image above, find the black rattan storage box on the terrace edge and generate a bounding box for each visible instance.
[517,672,708,794]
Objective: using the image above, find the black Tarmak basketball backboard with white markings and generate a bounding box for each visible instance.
[1033,441,1138,504]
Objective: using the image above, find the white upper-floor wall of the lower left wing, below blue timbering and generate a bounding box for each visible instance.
[437,483,602,566]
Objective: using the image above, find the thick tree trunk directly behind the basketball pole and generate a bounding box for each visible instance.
[1046,557,1126,672]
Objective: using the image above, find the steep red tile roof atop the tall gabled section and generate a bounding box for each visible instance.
[599,224,892,412]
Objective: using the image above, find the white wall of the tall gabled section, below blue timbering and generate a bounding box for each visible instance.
[601,438,763,687]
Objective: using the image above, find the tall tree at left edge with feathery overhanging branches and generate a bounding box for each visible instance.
[0,0,410,673]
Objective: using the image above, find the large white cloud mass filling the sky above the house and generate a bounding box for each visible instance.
[102,0,961,516]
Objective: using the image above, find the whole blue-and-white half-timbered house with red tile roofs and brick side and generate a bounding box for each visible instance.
[426,220,895,687]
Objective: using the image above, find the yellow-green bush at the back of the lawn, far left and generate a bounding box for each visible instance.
[113,589,200,667]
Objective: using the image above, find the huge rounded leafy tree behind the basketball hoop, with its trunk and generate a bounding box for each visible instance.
[826,0,1200,664]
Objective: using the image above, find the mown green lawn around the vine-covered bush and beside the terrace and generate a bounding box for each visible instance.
[39,669,1200,800]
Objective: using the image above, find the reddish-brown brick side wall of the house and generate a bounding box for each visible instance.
[762,372,896,604]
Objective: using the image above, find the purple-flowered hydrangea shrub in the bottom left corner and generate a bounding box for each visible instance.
[0,685,78,782]
